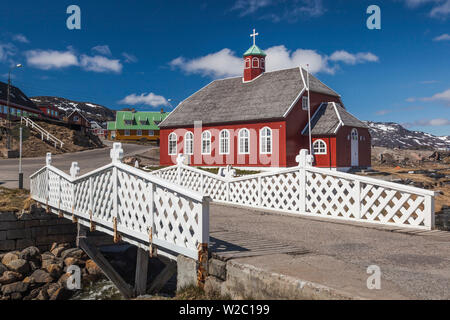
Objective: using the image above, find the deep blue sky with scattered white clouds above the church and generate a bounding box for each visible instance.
[0,0,450,135]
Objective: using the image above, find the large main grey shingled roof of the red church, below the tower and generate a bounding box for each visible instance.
[160,68,339,128]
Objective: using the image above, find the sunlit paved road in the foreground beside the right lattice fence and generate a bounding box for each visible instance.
[210,205,450,299]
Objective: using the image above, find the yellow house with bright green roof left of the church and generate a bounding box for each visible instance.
[108,111,170,141]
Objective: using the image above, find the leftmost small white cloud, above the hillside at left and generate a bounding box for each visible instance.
[25,50,78,70]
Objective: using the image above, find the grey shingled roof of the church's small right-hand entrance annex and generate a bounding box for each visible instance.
[302,102,367,135]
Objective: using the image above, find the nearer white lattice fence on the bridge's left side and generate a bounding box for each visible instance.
[30,144,209,259]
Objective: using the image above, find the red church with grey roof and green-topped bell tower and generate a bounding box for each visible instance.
[159,33,371,171]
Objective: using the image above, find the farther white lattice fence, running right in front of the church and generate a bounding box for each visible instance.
[153,151,434,229]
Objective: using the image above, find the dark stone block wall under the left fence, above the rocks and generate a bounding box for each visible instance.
[0,208,77,252]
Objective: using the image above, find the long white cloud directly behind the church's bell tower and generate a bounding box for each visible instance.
[169,45,379,78]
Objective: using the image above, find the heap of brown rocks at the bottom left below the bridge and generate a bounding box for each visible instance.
[0,243,104,300]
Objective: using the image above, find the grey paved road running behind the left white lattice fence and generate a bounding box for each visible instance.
[0,141,153,189]
